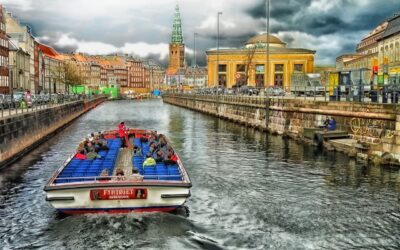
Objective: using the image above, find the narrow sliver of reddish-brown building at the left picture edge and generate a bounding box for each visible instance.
[0,4,10,94]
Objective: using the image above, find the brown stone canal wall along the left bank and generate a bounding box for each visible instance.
[0,97,105,168]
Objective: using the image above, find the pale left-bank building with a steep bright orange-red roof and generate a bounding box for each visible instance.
[38,43,68,94]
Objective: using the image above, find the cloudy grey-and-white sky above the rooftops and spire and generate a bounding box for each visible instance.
[0,0,400,65]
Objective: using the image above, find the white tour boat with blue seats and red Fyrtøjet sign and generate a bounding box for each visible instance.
[44,129,192,214]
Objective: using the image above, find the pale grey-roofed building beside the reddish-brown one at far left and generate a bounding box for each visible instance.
[4,11,37,93]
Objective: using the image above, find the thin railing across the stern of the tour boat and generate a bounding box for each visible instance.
[54,175,183,184]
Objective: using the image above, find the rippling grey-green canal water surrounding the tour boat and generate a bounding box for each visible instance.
[0,100,400,249]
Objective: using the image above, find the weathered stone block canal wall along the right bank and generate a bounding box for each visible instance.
[163,94,400,164]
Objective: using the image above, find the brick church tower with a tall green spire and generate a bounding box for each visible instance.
[168,4,185,75]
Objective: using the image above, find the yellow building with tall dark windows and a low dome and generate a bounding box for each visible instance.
[206,34,315,88]
